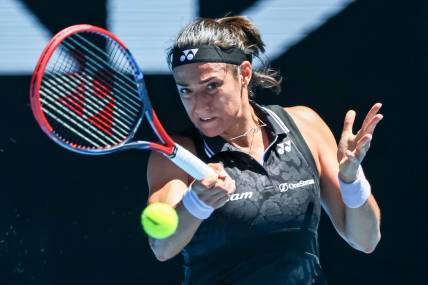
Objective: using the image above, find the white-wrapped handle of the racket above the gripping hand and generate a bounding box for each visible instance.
[169,144,215,180]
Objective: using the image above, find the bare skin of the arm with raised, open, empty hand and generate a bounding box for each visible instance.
[286,106,382,253]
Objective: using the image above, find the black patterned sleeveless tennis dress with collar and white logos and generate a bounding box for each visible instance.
[182,102,326,285]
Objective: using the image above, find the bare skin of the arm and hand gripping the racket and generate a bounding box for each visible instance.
[147,137,235,261]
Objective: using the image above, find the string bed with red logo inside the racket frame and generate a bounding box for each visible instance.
[41,31,142,148]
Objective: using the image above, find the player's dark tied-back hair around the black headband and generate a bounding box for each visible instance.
[167,16,282,96]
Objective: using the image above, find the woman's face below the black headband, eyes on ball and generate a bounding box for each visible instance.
[174,63,248,137]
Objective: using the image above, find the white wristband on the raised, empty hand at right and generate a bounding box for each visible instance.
[339,165,371,208]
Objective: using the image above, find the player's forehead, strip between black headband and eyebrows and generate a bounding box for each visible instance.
[173,62,227,84]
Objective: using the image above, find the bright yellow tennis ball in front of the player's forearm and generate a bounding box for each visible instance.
[141,203,178,239]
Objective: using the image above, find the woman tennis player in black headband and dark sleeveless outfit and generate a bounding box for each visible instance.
[148,17,382,285]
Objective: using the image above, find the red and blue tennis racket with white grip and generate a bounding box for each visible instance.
[30,25,214,180]
